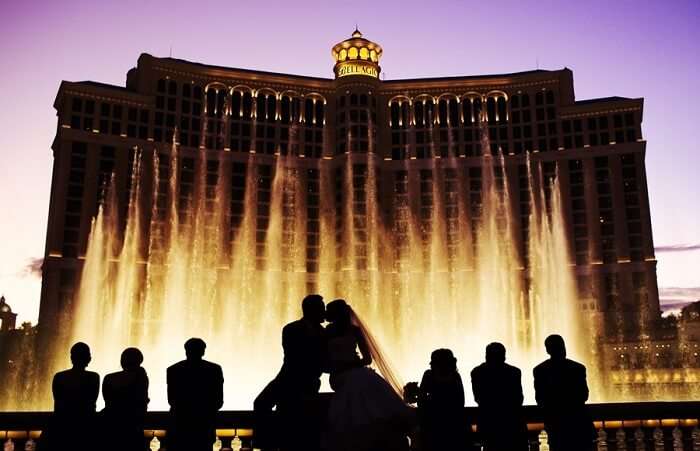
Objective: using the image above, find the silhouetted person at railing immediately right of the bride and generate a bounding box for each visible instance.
[418,349,471,451]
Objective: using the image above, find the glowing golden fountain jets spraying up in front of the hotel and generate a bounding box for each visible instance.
[26,108,586,409]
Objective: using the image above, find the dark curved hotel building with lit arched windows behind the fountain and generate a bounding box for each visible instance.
[39,31,660,350]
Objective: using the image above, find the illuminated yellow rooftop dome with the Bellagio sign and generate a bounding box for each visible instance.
[332,28,382,78]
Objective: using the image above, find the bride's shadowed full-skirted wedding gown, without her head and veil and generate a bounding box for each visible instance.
[328,328,411,451]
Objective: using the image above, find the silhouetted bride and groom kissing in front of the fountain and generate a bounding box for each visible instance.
[253,294,412,451]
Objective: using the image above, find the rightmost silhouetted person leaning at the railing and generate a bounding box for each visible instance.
[533,335,595,451]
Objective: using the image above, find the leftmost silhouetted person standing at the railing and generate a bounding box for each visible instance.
[45,342,100,451]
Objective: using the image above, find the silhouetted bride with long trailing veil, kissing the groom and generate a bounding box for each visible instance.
[326,299,412,451]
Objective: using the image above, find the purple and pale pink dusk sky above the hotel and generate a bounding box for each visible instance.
[0,0,700,321]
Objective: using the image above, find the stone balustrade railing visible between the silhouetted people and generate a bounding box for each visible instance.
[0,402,700,451]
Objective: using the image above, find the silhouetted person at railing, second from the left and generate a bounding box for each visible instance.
[102,348,148,451]
